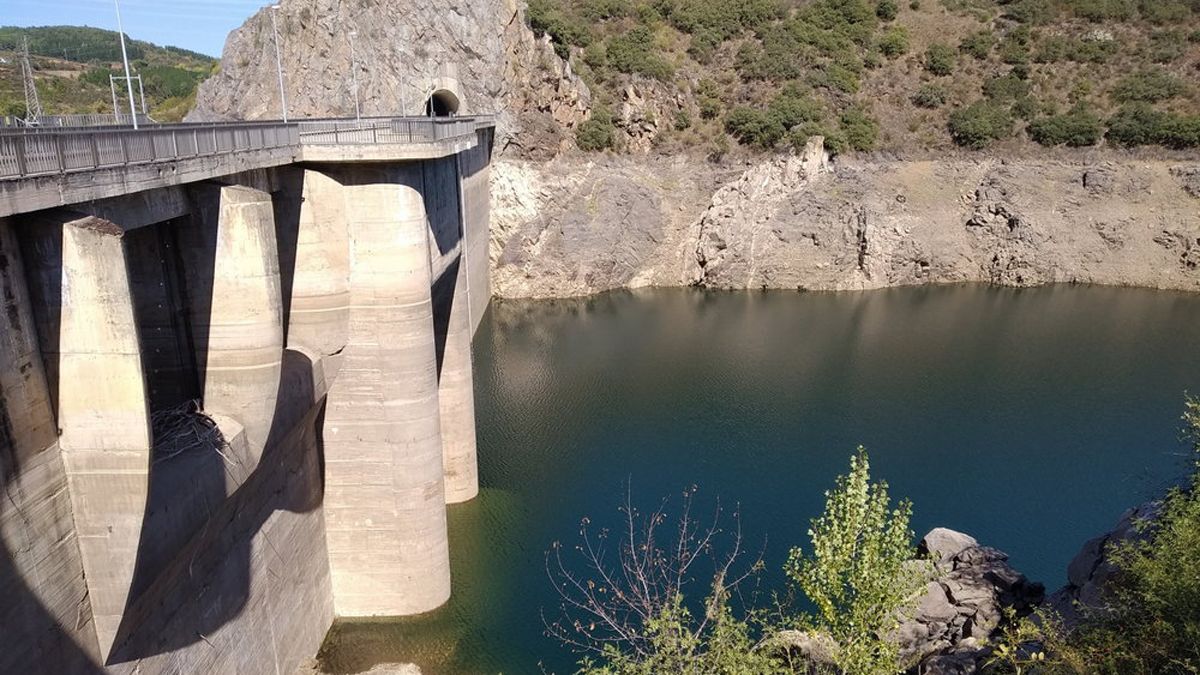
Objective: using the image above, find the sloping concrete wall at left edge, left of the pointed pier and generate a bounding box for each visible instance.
[0,219,100,673]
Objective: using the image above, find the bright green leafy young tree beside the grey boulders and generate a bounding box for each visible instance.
[785,448,929,675]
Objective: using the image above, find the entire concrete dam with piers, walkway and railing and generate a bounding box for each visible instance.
[0,117,494,674]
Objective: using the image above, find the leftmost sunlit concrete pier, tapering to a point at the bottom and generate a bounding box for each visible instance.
[58,216,151,656]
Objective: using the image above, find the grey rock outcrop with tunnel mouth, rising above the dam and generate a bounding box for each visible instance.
[188,0,590,157]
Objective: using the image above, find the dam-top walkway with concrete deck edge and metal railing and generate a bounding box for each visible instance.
[0,115,496,217]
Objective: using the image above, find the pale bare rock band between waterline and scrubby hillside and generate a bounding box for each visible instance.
[492,149,1200,297]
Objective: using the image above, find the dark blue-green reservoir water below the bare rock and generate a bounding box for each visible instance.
[324,287,1200,675]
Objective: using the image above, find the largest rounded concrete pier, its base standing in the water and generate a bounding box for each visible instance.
[325,168,450,616]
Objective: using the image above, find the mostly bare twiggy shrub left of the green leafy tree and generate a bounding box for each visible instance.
[546,488,784,675]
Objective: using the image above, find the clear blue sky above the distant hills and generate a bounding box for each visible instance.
[0,0,269,56]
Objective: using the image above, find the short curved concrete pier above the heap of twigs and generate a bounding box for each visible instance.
[185,185,283,458]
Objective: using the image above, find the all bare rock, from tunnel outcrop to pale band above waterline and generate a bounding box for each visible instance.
[191,0,1200,297]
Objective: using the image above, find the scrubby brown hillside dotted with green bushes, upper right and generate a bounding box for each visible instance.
[529,0,1200,154]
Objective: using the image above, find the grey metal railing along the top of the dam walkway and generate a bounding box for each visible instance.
[0,117,494,180]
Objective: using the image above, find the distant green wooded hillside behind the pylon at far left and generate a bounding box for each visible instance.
[0,26,216,121]
